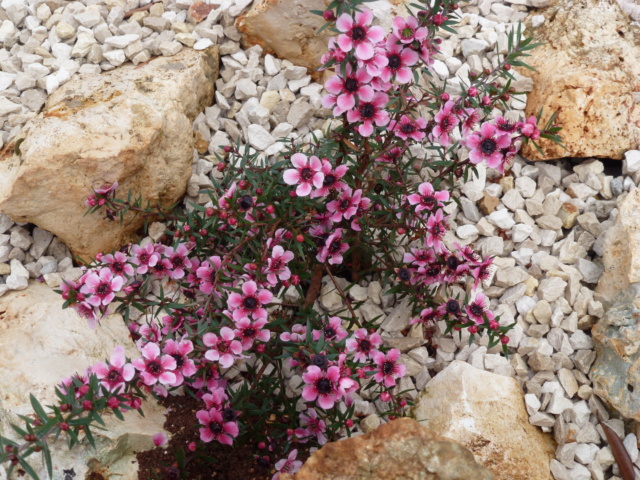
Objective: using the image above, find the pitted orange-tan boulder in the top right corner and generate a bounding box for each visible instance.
[521,0,640,160]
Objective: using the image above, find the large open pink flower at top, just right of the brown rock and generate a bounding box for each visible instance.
[336,10,384,60]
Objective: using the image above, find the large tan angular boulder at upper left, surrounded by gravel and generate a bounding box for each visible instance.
[0,47,218,259]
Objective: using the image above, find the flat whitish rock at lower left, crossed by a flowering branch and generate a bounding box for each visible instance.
[0,283,165,480]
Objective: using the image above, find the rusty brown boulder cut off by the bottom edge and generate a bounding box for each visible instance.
[280,418,493,480]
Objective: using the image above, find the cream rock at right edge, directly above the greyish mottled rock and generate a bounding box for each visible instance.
[594,189,640,305]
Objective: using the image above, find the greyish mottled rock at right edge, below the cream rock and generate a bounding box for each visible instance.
[589,286,640,421]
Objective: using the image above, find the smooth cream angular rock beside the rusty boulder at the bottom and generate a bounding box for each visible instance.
[413,360,555,480]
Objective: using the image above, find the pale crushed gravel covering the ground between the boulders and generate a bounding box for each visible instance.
[0,0,640,480]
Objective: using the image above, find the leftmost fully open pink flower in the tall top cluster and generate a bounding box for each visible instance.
[322,66,375,117]
